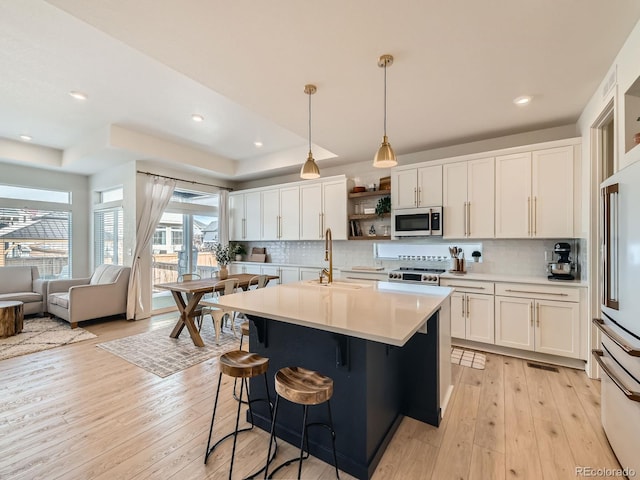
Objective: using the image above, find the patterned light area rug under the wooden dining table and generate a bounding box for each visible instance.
[97,321,241,378]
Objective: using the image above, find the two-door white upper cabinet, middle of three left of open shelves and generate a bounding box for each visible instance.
[261,186,300,240]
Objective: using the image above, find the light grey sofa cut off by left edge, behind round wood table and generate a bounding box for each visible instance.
[0,266,47,315]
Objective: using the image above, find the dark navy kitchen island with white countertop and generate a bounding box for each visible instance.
[220,281,452,479]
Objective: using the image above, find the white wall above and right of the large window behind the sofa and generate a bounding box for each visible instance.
[1,163,91,277]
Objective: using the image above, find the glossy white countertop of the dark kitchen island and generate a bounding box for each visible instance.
[212,280,453,346]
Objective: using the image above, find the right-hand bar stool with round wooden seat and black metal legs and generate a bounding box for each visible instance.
[264,367,340,479]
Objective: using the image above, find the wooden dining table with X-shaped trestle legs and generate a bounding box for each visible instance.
[154,273,279,347]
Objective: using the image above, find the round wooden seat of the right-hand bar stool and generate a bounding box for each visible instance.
[276,367,333,405]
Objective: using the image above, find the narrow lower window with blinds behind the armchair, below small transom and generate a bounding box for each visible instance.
[94,208,124,265]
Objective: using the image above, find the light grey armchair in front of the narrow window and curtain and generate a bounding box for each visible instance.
[47,265,131,328]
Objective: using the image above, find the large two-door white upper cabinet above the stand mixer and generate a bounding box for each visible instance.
[496,146,574,238]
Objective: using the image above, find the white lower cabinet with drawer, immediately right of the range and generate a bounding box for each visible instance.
[440,279,494,343]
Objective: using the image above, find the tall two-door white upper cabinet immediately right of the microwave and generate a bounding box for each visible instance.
[442,157,495,238]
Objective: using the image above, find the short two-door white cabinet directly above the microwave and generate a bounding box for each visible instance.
[391,165,442,210]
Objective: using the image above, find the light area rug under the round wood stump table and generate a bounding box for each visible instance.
[0,317,96,360]
